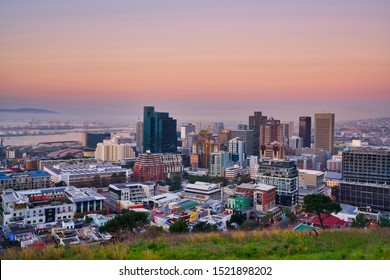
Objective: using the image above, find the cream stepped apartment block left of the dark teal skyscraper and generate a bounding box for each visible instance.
[95,136,135,162]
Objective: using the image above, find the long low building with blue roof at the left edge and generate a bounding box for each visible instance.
[0,170,54,192]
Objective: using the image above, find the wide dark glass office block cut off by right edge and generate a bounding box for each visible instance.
[339,148,390,211]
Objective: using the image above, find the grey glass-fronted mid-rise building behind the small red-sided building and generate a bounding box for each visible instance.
[257,159,298,207]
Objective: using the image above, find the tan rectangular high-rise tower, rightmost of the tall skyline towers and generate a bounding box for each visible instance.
[314,113,335,153]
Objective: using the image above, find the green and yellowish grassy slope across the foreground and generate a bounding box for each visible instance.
[2,229,390,260]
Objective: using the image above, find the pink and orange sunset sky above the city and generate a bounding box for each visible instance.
[0,0,390,122]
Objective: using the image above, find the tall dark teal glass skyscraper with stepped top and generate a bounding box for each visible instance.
[143,106,177,153]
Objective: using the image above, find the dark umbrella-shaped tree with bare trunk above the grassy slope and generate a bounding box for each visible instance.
[303,194,341,228]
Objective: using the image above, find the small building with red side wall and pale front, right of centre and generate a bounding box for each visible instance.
[253,184,276,212]
